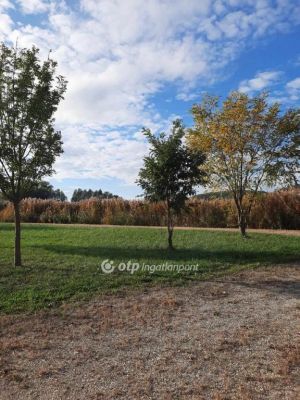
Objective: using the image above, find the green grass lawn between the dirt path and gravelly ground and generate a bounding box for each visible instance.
[0,224,300,313]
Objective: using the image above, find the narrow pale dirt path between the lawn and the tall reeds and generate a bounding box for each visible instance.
[24,223,300,236]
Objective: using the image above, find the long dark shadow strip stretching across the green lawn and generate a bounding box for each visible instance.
[35,244,299,265]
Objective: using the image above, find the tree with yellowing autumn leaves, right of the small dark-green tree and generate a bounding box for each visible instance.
[187,92,300,237]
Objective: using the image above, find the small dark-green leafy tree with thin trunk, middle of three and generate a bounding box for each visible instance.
[137,120,206,250]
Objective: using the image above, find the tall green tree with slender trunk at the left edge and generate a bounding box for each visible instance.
[0,44,66,266]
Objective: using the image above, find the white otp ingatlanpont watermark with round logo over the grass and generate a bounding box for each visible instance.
[101,259,198,274]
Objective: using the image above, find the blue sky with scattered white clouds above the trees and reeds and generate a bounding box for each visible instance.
[0,0,300,199]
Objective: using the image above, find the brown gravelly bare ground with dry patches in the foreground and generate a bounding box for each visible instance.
[0,265,300,400]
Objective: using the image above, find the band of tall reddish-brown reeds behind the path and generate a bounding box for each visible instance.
[0,189,300,229]
